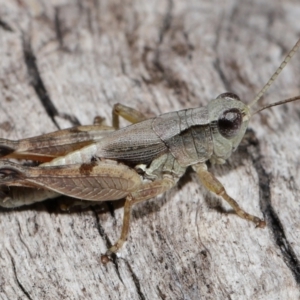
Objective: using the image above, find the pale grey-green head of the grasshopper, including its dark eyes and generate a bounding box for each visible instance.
[208,93,250,164]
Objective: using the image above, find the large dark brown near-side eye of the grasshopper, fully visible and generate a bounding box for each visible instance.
[217,108,243,138]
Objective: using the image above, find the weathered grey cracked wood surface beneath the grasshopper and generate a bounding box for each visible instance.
[0,0,300,299]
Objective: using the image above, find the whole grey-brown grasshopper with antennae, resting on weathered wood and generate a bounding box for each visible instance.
[0,39,300,262]
